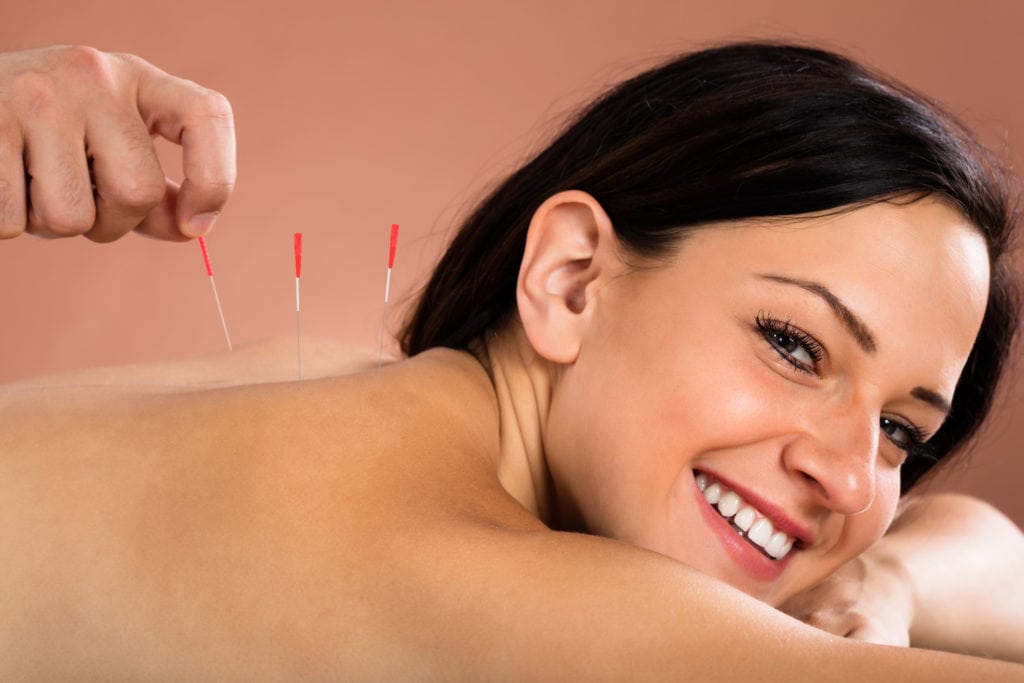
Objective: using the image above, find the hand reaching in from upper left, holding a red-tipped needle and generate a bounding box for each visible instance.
[0,47,236,242]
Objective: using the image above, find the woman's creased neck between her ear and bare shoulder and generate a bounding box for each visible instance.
[481,322,557,525]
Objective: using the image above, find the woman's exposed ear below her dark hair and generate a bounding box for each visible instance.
[516,190,622,362]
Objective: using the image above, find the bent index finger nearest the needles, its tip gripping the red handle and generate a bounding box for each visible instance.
[128,53,236,237]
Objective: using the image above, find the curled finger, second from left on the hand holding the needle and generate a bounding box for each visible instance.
[25,122,96,237]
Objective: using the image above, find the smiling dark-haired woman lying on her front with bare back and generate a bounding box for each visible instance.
[0,45,1024,680]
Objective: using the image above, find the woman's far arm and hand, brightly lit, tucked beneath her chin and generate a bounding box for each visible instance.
[782,494,1024,661]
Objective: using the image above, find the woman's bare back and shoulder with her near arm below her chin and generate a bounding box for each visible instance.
[0,342,1020,680]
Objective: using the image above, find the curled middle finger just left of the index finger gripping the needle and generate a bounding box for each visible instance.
[86,105,165,242]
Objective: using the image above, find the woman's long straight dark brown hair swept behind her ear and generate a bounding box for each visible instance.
[399,43,1018,490]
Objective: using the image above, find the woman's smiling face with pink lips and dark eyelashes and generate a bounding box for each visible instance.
[545,199,989,604]
